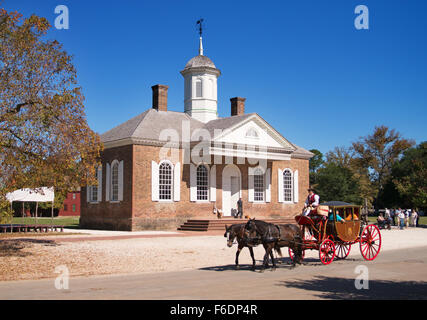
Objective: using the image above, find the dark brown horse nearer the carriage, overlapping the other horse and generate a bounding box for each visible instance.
[245,219,303,271]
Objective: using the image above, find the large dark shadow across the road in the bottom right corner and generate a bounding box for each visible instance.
[277,276,427,300]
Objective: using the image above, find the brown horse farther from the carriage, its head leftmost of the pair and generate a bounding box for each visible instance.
[224,223,282,270]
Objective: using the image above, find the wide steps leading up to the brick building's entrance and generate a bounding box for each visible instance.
[178,217,295,232]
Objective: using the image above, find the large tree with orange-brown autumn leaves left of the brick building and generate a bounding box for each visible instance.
[0,9,102,211]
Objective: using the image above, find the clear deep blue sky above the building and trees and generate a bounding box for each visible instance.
[1,0,427,152]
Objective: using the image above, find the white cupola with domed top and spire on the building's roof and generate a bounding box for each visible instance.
[181,37,221,123]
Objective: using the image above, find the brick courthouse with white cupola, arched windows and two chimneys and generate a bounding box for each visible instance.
[80,38,312,230]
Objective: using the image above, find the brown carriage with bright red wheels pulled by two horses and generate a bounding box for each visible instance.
[289,202,381,264]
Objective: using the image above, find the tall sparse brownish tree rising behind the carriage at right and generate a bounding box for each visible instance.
[352,126,414,208]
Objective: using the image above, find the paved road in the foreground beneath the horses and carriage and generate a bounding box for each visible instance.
[0,247,427,300]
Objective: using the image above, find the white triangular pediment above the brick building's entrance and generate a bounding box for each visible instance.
[214,114,295,151]
